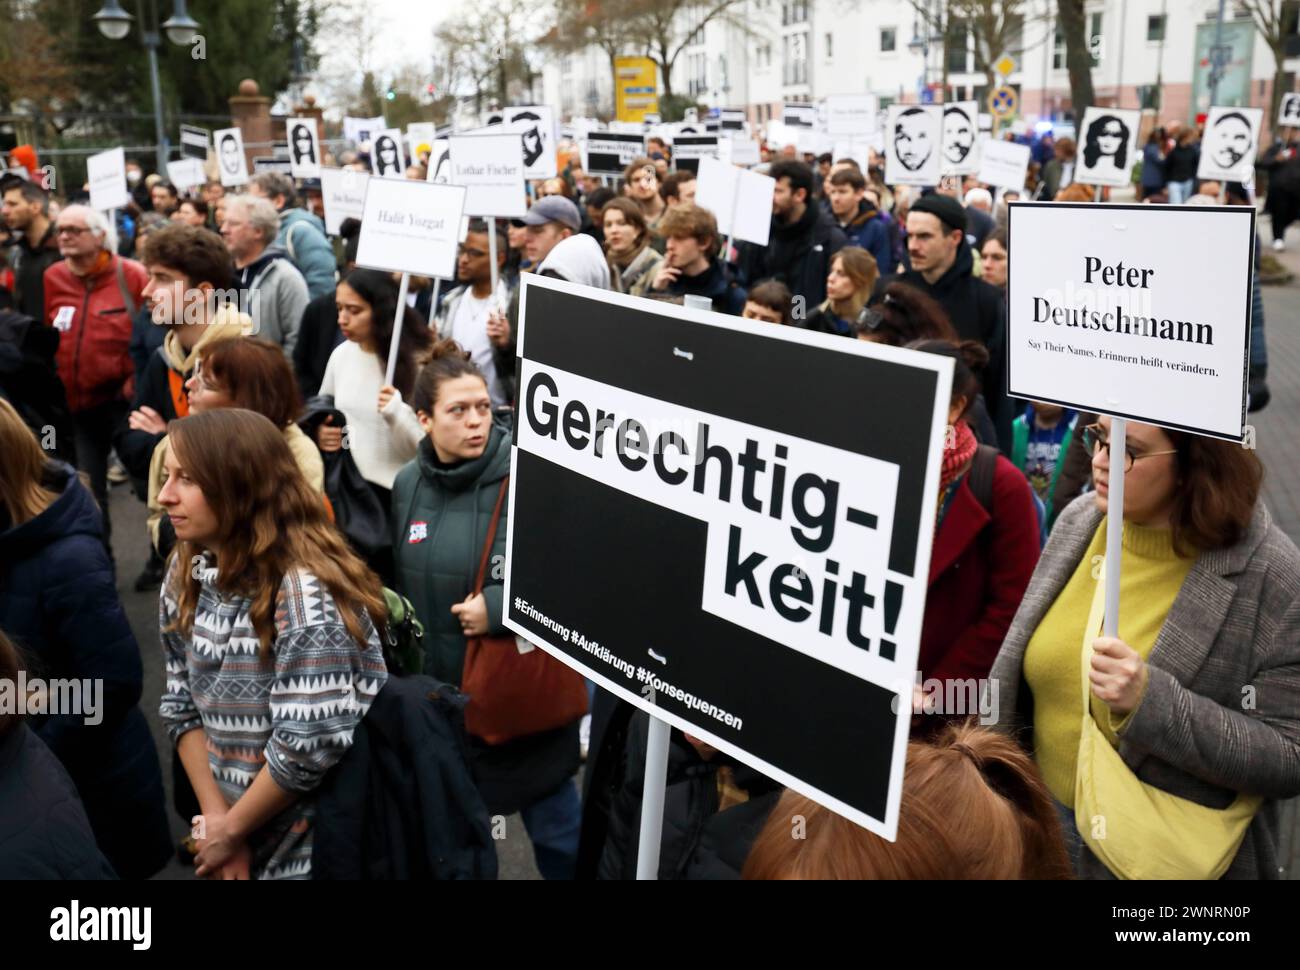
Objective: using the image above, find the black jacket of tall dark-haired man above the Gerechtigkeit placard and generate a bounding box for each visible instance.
[736,203,848,307]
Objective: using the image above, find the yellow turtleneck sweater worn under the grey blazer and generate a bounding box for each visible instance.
[1024,519,1195,807]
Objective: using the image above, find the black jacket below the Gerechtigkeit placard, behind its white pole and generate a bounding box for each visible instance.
[579,696,783,879]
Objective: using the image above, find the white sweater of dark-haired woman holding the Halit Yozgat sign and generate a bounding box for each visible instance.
[320,341,424,489]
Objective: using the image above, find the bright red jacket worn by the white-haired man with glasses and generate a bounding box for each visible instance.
[46,255,148,412]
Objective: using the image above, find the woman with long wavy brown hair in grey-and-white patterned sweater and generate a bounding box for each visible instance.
[159,408,387,879]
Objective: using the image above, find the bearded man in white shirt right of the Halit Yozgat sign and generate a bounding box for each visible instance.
[438,218,511,407]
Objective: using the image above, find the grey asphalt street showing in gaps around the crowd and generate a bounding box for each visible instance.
[111,218,1300,879]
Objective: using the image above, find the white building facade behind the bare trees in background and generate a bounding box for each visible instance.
[543,0,1300,133]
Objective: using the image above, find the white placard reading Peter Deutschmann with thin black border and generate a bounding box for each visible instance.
[1006,202,1255,441]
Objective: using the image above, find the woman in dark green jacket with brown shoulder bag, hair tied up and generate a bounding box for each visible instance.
[391,339,581,879]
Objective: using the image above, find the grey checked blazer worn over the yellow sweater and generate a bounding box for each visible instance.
[988,494,1300,879]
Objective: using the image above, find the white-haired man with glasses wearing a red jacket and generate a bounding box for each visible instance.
[44,205,148,558]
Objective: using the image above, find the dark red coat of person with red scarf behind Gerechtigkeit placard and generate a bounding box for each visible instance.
[920,455,1039,680]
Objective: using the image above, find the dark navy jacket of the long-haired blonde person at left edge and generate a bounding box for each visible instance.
[0,463,172,879]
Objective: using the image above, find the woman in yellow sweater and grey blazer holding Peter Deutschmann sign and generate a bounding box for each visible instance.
[991,417,1300,879]
